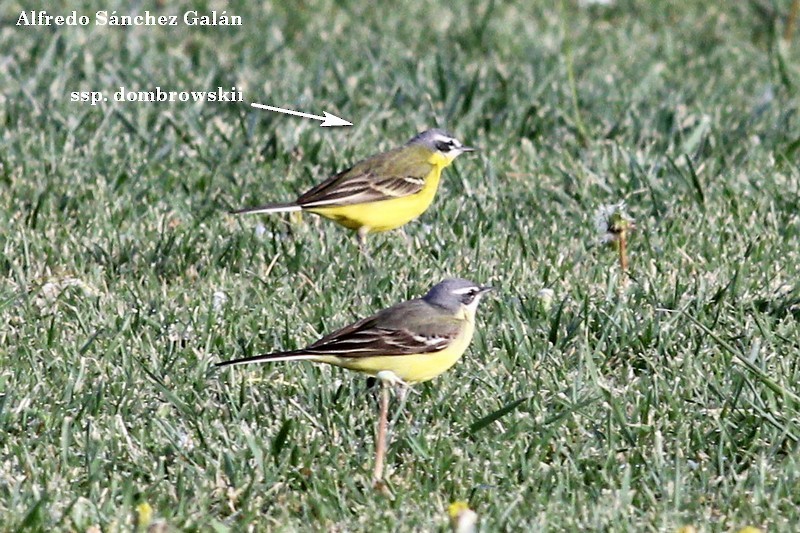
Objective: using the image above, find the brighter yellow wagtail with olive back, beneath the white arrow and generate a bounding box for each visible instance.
[232,129,475,243]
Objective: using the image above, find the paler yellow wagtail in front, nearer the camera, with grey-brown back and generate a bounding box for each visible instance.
[217,279,492,383]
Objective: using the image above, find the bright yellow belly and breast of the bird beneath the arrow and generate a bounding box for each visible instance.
[308,169,441,233]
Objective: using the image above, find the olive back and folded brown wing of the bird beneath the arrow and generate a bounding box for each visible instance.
[297,150,433,208]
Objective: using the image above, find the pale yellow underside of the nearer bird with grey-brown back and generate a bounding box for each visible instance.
[318,321,475,383]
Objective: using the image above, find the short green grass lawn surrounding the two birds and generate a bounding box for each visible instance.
[0,0,800,531]
